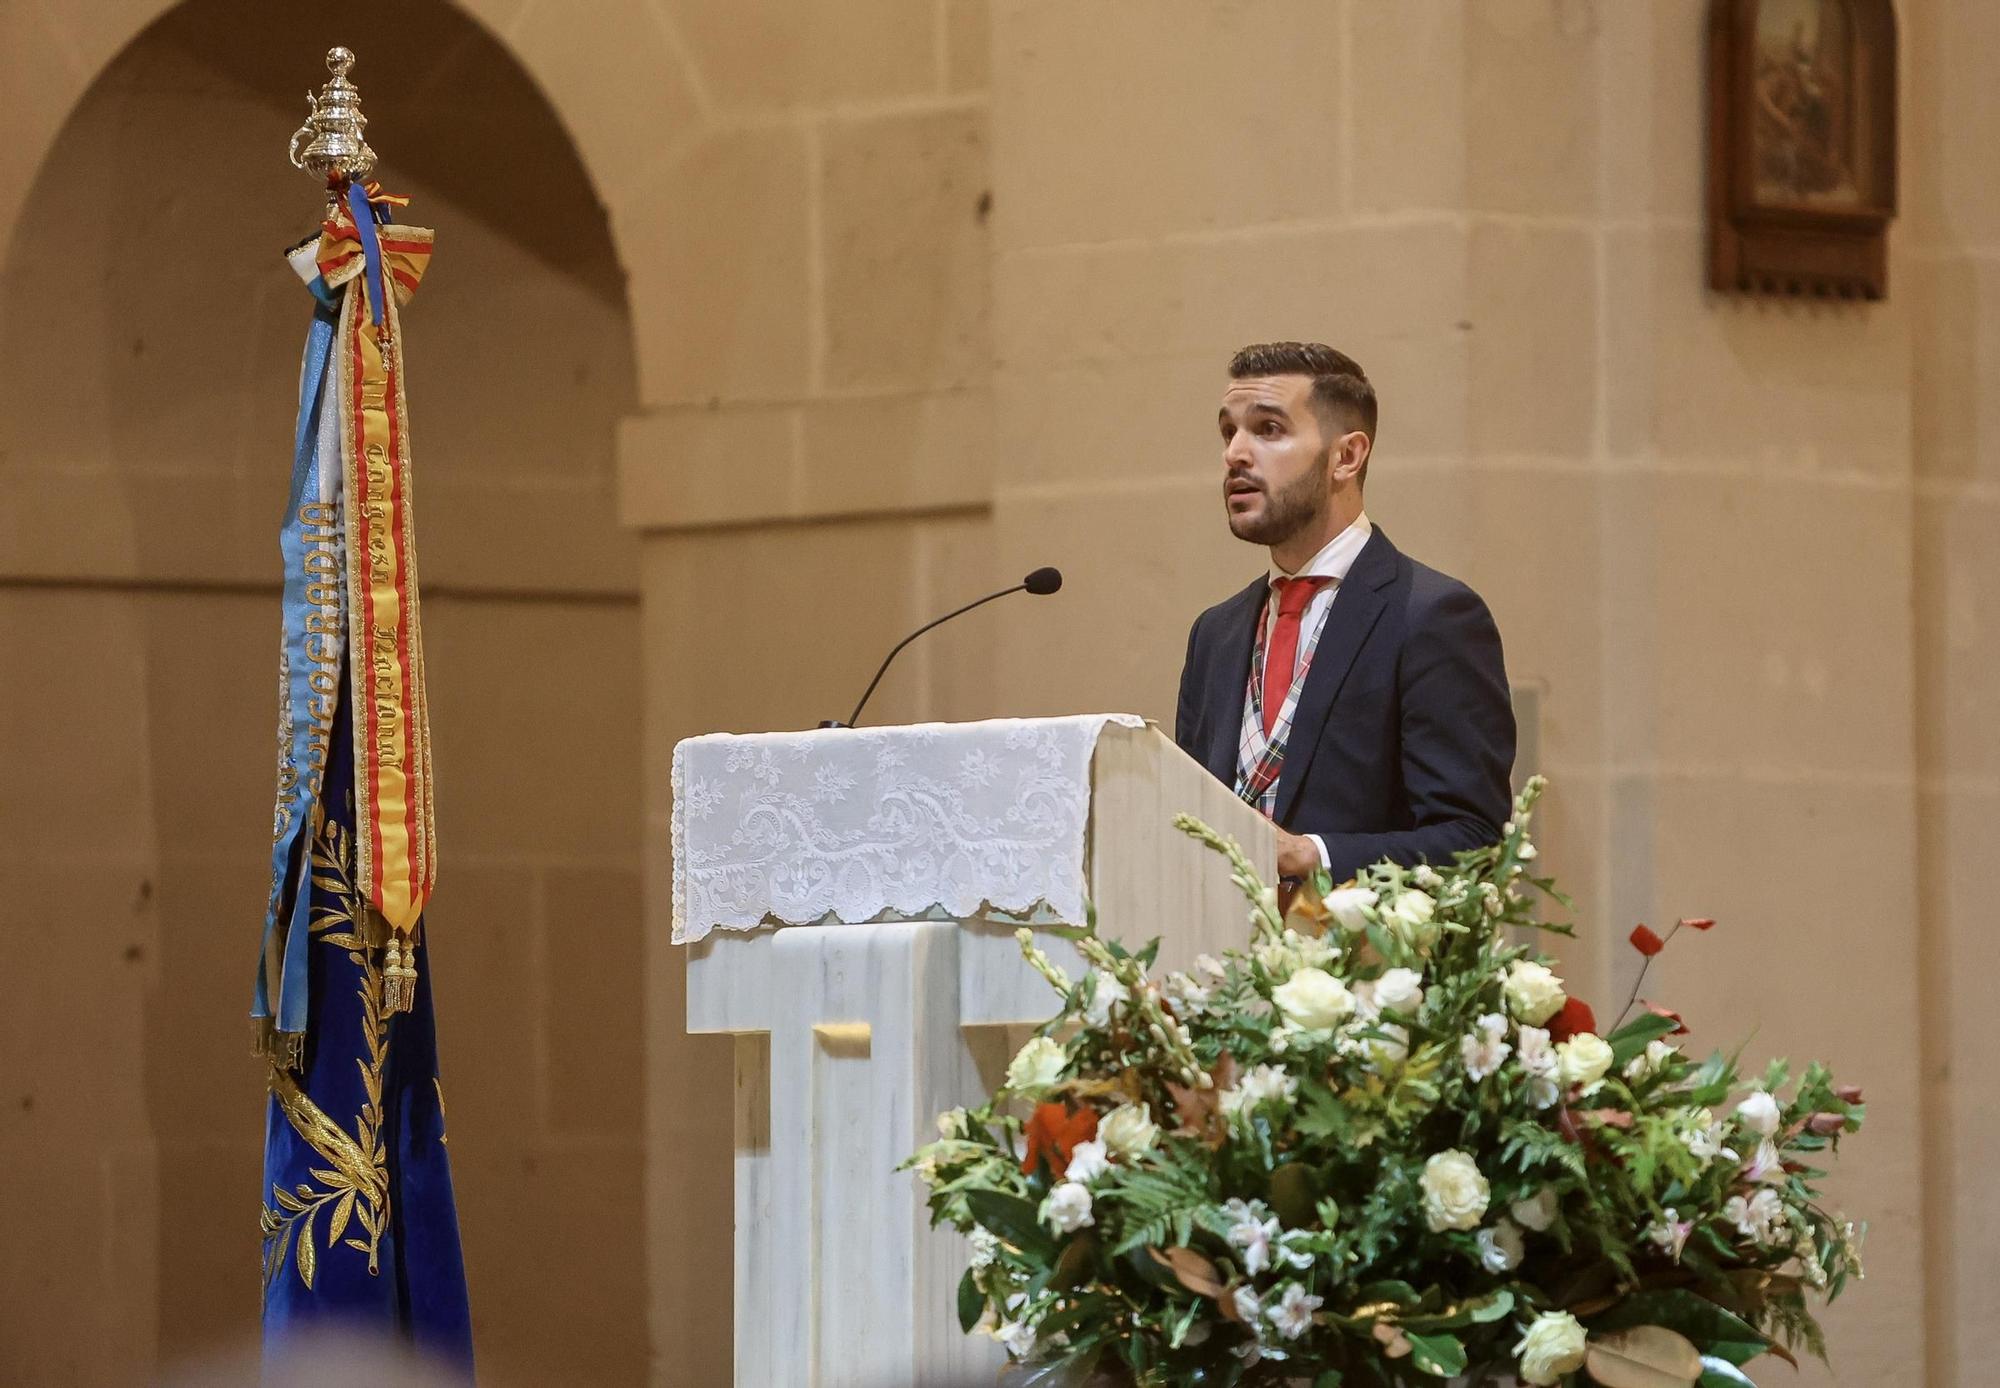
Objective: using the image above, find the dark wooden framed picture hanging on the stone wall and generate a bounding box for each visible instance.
[1708,0,1896,298]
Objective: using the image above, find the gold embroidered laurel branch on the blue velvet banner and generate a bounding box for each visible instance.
[258,810,388,1292]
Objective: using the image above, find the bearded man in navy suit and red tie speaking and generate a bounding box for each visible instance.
[1174,342,1514,882]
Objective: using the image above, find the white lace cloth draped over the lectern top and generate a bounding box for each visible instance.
[674,714,1144,944]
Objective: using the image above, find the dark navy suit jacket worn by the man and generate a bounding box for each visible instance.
[1174,530,1514,882]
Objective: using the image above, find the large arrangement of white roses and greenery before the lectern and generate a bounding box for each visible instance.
[908,778,1862,1388]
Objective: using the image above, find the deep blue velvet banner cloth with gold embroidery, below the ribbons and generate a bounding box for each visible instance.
[262,692,472,1380]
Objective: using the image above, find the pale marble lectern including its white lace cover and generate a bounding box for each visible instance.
[674,716,1276,1388]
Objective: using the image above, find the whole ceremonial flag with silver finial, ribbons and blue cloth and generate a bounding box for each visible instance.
[252,50,472,1376]
